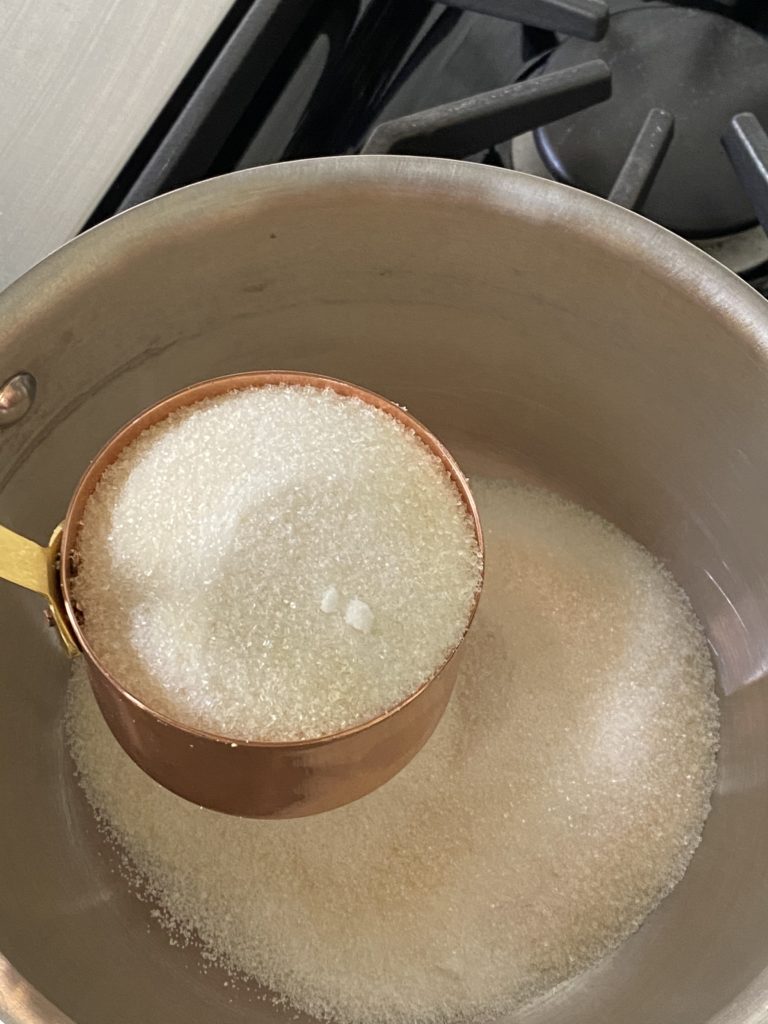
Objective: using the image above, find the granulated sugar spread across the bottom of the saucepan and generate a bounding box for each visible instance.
[69,481,717,1024]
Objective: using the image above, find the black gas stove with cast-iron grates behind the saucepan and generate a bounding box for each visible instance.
[87,0,768,295]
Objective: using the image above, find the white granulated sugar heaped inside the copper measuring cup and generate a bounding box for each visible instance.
[75,385,480,740]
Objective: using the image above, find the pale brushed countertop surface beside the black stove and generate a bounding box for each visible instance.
[0,0,231,289]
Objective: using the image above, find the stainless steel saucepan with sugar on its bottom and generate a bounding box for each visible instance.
[0,157,768,1024]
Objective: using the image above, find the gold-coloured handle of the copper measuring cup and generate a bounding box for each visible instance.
[0,524,79,656]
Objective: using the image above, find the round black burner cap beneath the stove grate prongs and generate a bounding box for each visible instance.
[535,3,768,239]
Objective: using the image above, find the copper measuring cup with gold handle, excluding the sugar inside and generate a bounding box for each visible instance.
[0,372,483,818]
